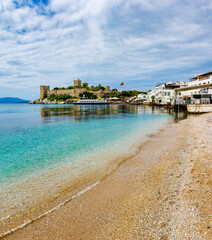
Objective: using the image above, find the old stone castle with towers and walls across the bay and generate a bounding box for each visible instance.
[40,78,110,100]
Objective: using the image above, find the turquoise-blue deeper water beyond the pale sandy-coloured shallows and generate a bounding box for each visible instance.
[0,104,170,183]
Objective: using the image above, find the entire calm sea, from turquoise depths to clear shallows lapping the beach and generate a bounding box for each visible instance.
[0,104,186,236]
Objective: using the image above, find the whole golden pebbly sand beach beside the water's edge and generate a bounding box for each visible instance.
[4,113,212,240]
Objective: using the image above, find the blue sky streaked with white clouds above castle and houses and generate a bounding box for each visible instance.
[0,0,212,100]
